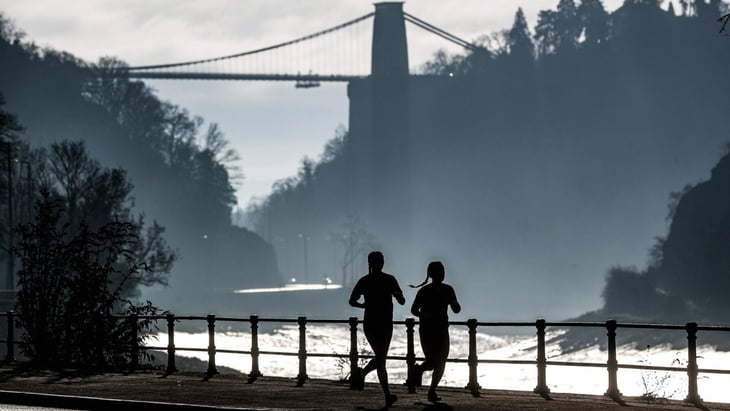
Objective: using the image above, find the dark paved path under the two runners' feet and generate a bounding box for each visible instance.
[0,367,730,411]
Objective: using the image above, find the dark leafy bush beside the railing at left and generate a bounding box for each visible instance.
[15,192,163,369]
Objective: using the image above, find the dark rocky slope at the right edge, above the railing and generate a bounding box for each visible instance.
[560,153,730,350]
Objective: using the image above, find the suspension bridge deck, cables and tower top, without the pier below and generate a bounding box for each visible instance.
[117,2,484,88]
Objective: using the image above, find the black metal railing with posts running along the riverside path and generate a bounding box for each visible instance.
[0,311,730,406]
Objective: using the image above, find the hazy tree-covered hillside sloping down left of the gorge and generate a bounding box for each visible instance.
[0,16,281,312]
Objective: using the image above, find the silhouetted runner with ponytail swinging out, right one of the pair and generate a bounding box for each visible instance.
[411,261,461,402]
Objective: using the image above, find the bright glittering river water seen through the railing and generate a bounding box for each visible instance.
[147,324,730,403]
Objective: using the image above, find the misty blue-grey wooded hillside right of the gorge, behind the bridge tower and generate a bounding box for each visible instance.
[250,0,730,319]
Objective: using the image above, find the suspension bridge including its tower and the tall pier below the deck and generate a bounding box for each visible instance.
[116,2,487,237]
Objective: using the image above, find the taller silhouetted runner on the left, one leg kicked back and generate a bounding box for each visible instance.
[349,251,406,407]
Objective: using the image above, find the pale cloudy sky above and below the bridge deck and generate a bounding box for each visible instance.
[0,0,623,206]
